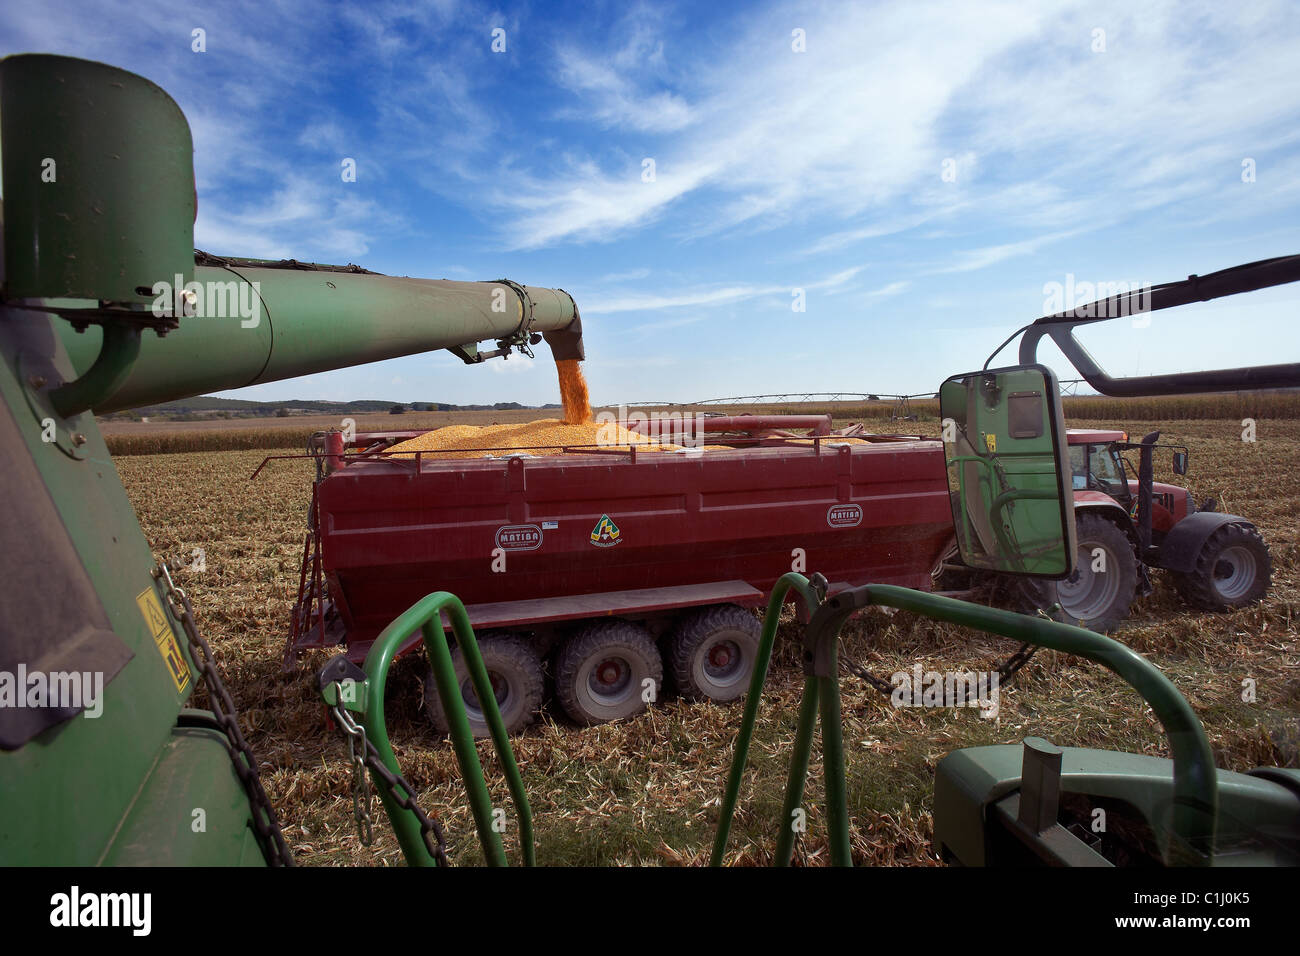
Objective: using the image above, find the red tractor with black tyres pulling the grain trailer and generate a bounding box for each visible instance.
[1018,429,1271,631]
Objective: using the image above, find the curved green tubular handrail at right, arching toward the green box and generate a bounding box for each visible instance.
[710,574,1218,866]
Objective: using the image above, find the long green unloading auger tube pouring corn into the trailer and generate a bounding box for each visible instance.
[59,265,577,414]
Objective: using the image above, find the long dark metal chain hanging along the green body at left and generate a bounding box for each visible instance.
[153,562,294,866]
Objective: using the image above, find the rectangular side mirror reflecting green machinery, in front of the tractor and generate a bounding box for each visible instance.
[939,365,1076,578]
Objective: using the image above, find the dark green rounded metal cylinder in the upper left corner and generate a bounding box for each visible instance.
[0,55,195,306]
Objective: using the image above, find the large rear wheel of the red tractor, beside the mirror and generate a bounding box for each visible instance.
[1015,514,1138,633]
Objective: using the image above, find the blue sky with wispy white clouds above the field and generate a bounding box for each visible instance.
[0,0,1300,403]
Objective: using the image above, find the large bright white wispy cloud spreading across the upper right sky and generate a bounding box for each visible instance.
[452,3,1300,261]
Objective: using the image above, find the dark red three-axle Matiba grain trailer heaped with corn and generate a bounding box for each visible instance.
[285,416,952,731]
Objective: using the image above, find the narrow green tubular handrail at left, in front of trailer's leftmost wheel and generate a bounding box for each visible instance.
[364,591,536,866]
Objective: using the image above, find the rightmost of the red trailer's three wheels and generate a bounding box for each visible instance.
[668,604,762,704]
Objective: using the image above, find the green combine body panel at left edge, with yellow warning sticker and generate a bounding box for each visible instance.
[0,299,266,866]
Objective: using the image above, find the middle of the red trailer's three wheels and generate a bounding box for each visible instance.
[555,620,663,726]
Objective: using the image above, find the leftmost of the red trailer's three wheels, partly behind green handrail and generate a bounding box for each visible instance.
[424,633,542,737]
